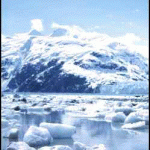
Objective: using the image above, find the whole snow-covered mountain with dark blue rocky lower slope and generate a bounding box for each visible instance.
[1,28,149,94]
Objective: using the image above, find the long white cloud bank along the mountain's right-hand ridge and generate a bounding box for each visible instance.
[51,23,148,58]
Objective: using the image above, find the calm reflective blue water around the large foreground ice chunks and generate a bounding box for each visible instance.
[2,111,148,150]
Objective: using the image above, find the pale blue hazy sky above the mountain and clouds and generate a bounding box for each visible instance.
[2,0,148,40]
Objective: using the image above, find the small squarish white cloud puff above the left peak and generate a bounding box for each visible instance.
[31,19,43,31]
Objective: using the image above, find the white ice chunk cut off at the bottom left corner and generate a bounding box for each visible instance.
[7,142,35,150]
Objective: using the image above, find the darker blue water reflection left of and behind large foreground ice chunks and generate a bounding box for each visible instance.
[1,111,62,150]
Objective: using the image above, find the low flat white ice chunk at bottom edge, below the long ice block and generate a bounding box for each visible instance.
[38,145,72,150]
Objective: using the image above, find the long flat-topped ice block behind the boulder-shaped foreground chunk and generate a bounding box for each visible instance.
[40,122,76,138]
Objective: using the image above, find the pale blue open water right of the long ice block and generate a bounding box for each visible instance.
[73,119,148,150]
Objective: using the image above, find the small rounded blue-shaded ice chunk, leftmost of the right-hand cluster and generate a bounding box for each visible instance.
[112,112,126,123]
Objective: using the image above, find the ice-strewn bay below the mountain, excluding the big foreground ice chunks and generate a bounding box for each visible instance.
[1,93,149,150]
